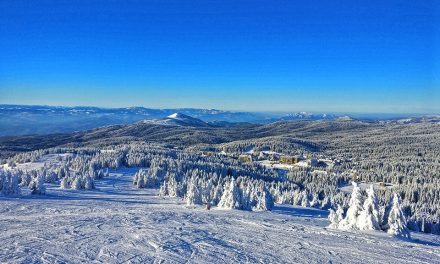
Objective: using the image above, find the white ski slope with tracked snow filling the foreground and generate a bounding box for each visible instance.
[0,169,440,263]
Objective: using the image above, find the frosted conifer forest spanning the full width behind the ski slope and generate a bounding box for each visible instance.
[3,134,440,234]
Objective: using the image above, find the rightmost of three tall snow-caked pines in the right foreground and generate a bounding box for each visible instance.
[387,194,410,238]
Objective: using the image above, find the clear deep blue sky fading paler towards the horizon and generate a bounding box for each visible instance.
[0,0,440,113]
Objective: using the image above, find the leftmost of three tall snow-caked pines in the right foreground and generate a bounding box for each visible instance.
[339,181,362,229]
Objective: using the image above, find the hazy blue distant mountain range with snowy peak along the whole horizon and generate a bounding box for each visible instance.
[0,105,440,136]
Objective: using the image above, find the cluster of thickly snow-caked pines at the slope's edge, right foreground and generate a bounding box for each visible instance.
[329,182,410,238]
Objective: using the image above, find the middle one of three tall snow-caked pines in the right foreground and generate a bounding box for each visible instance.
[358,185,381,230]
